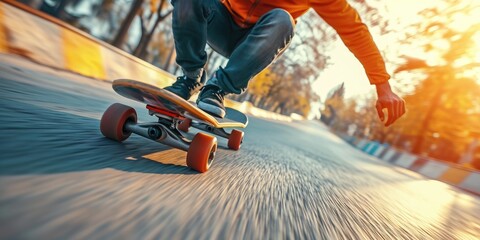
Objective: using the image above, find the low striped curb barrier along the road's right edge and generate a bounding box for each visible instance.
[341,135,480,195]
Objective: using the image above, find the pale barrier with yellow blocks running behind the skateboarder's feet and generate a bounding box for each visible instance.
[0,0,292,121]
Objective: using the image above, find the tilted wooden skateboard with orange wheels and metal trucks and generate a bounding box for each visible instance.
[100,79,248,172]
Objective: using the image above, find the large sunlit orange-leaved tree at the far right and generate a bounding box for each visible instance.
[396,0,480,158]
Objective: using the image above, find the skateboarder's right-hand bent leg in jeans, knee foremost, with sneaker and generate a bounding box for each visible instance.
[197,9,295,117]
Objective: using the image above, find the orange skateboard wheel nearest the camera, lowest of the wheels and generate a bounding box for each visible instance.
[187,133,217,173]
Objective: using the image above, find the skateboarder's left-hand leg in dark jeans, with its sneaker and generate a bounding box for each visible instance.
[165,0,237,100]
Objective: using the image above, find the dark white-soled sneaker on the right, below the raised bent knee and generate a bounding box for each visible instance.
[197,84,227,118]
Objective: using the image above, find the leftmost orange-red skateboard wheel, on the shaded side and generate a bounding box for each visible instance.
[100,103,137,142]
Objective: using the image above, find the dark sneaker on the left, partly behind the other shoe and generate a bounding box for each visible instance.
[164,72,206,101]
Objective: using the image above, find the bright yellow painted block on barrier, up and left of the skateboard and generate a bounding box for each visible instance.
[61,28,105,79]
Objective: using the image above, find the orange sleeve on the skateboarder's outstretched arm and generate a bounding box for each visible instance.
[311,0,390,84]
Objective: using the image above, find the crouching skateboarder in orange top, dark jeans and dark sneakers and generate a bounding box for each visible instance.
[166,0,405,126]
